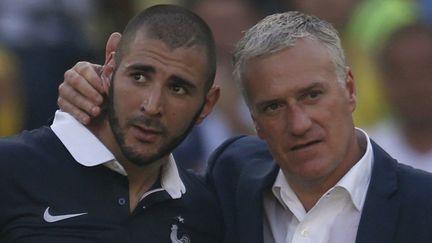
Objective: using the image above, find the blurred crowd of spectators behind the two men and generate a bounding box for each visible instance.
[0,0,432,172]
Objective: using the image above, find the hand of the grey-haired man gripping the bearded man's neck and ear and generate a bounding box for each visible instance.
[57,62,108,125]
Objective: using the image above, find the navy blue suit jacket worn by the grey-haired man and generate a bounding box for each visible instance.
[207,136,432,243]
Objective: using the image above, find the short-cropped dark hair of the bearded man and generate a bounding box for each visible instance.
[116,4,216,91]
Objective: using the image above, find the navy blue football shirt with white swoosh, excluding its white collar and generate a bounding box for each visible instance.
[0,127,223,243]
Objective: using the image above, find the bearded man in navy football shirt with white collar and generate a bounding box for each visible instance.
[0,5,222,243]
